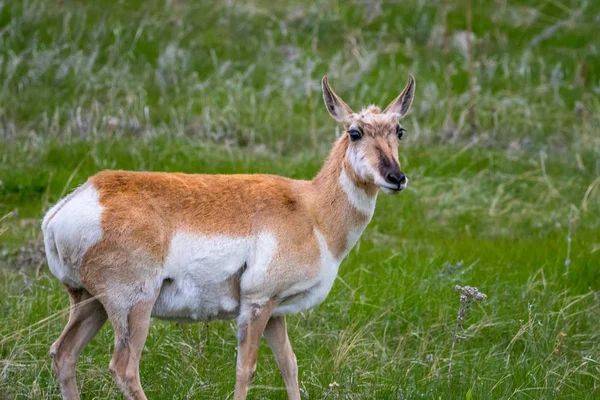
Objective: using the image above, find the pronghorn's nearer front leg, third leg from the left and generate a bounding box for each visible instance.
[234,300,279,400]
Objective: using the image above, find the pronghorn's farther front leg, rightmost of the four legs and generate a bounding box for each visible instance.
[265,315,300,400]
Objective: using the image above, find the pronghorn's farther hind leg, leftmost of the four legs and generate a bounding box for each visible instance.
[50,288,106,400]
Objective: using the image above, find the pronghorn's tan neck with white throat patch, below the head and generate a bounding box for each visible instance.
[312,135,379,259]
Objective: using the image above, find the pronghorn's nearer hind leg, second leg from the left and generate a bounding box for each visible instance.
[108,301,154,400]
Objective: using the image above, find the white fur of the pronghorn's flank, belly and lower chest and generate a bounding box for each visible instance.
[152,230,341,322]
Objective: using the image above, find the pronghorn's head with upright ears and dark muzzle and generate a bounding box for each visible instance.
[321,75,415,194]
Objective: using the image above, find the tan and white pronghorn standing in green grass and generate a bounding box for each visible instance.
[42,75,415,399]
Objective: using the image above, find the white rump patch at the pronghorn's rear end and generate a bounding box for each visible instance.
[42,184,102,288]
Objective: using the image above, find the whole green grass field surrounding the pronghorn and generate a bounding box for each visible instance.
[0,0,600,399]
